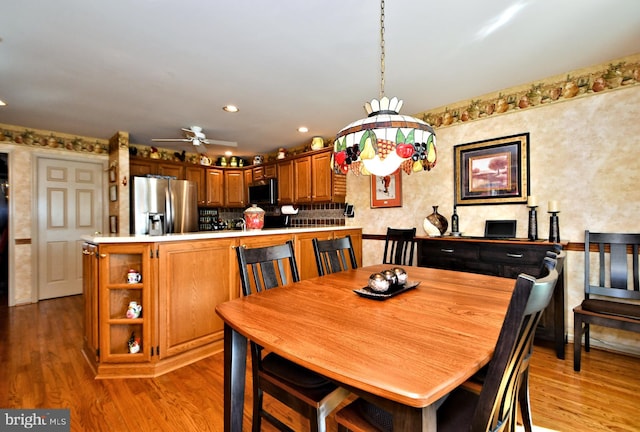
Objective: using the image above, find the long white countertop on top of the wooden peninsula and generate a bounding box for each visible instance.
[81,226,360,244]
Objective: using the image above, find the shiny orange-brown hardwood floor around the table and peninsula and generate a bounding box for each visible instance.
[0,296,640,432]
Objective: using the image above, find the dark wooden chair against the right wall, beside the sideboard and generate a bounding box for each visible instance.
[573,230,640,372]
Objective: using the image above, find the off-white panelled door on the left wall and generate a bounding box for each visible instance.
[37,158,104,300]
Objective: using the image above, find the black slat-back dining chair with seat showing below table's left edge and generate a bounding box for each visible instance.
[236,241,349,432]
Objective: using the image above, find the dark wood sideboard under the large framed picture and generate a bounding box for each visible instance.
[416,237,567,359]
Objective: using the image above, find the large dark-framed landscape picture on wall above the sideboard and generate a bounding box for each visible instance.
[453,132,529,206]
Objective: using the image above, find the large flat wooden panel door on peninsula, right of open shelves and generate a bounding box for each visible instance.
[158,238,240,359]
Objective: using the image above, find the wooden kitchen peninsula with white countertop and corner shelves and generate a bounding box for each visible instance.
[82,226,362,378]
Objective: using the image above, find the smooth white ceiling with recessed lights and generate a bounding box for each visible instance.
[0,0,640,159]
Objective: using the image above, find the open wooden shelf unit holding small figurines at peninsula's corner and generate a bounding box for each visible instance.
[98,244,153,363]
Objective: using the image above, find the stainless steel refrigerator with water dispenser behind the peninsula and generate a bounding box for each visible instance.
[130,176,198,235]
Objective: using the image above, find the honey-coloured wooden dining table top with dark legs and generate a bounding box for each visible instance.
[216,264,515,431]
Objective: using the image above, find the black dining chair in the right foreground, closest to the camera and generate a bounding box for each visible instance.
[336,258,558,432]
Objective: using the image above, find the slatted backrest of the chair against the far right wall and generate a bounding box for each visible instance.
[584,230,640,299]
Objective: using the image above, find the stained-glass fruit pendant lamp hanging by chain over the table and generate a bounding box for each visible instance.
[332,0,437,177]
